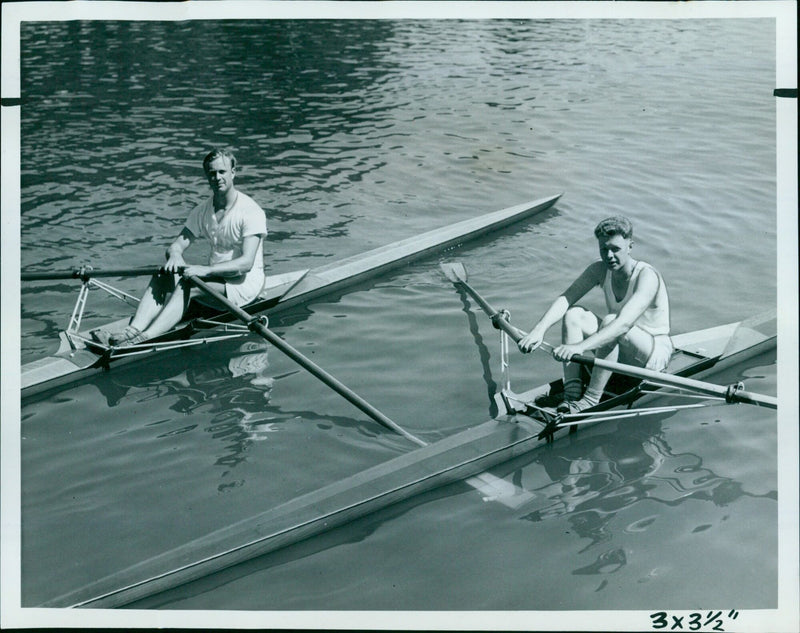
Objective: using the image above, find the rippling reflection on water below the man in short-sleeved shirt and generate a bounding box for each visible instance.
[80,340,394,484]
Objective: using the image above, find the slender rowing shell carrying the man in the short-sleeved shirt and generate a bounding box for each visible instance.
[21,194,561,398]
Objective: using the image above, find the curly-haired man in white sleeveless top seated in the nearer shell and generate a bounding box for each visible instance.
[518,216,672,413]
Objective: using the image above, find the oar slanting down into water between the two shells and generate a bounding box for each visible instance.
[188,275,427,446]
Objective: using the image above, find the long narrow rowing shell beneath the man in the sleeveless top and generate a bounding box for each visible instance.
[40,314,777,608]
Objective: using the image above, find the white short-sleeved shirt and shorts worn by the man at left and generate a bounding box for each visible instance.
[184,191,267,305]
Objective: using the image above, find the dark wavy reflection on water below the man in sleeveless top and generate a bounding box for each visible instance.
[514,414,777,574]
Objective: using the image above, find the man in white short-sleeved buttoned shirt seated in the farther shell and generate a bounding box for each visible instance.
[92,149,267,346]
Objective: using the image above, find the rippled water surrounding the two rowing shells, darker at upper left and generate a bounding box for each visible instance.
[15,12,777,610]
